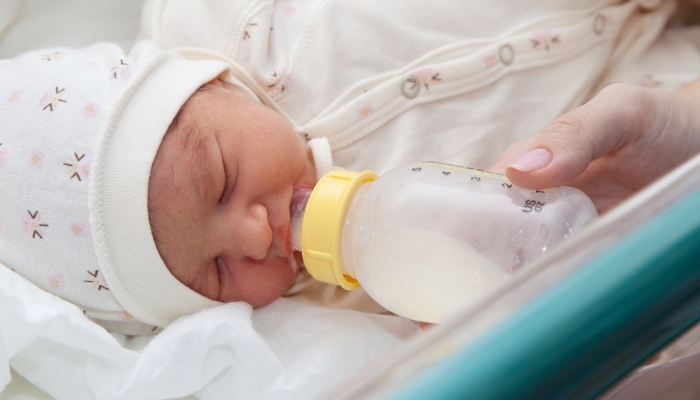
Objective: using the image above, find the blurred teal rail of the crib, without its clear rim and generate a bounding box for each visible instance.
[387,190,700,400]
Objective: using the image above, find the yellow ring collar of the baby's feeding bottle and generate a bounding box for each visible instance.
[301,171,377,290]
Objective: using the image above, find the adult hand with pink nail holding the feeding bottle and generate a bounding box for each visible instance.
[491,80,700,213]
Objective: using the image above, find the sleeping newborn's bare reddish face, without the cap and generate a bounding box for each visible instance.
[148,80,316,306]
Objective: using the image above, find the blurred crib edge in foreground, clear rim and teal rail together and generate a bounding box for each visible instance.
[327,152,700,400]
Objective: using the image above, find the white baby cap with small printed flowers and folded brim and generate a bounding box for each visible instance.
[0,41,229,330]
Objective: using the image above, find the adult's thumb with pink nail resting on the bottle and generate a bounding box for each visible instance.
[506,84,656,189]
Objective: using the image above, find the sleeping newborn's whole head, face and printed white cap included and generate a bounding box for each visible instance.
[0,41,326,335]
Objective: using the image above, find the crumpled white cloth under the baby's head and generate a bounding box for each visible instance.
[0,266,419,399]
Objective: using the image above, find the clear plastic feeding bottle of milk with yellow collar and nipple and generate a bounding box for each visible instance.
[290,162,598,322]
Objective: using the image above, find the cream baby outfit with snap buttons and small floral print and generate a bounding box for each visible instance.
[141,0,700,312]
